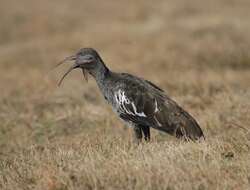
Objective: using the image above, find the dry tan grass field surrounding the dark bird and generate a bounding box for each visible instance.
[0,0,250,190]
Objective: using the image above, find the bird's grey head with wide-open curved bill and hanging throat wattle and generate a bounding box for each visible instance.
[57,48,106,85]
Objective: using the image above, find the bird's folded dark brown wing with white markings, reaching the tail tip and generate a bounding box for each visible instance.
[115,75,203,139]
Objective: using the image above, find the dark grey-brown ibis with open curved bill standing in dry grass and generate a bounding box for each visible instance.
[57,48,204,142]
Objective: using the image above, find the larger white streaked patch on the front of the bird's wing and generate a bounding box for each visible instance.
[115,89,147,117]
